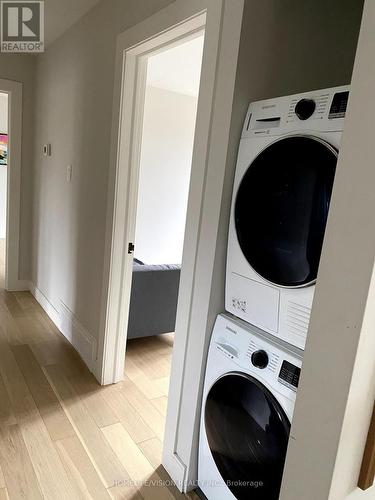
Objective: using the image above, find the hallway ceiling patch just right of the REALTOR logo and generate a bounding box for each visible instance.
[44,0,100,46]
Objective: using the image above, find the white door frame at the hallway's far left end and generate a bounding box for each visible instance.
[0,79,24,290]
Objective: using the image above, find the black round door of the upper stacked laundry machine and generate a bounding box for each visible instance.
[234,136,337,287]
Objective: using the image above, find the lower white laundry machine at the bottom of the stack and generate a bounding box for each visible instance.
[198,314,303,500]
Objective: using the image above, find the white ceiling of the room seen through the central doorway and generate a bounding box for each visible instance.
[147,34,204,97]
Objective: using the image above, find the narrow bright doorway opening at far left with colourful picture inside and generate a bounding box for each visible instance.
[0,92,9,289]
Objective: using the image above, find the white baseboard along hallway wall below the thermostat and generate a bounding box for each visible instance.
[29,283,97,372]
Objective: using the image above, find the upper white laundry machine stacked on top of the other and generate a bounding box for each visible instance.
[225,86,349,349]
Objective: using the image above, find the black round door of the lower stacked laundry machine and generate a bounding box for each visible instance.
[204,373,290,500]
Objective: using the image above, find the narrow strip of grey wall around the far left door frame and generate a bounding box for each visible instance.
[0,54,36,280]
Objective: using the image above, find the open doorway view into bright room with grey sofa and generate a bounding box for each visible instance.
[125,31,204,376]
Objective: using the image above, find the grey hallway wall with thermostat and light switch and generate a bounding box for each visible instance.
[32,0,175,337]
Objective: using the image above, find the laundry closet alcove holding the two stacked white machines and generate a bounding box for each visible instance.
[191,0,370,500]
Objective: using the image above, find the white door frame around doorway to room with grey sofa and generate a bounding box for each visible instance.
[94,0,243,490]
